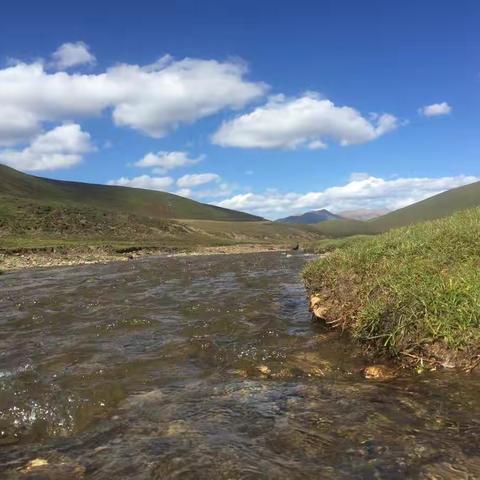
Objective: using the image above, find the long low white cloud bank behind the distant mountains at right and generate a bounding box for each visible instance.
[217,174,480,218]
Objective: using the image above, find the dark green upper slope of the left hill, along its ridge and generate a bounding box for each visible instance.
[0,165,261,221]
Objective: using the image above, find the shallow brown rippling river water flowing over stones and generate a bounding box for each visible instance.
[0,253,480,480]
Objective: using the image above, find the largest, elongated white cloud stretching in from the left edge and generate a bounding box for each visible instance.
[0,52,267,145]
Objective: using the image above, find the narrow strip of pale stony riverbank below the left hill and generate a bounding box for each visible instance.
[0,244,291,273]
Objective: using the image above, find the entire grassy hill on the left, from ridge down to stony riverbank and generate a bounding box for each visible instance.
[0,165,320,253]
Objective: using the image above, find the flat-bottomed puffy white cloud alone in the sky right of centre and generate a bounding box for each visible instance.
[213,92,399,149]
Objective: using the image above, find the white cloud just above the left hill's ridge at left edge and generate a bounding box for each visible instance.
[0,123,94,171]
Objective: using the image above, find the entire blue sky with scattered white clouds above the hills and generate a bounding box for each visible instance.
[0,0,480,218]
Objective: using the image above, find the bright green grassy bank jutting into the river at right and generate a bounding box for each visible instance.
[304,208,480,367]
